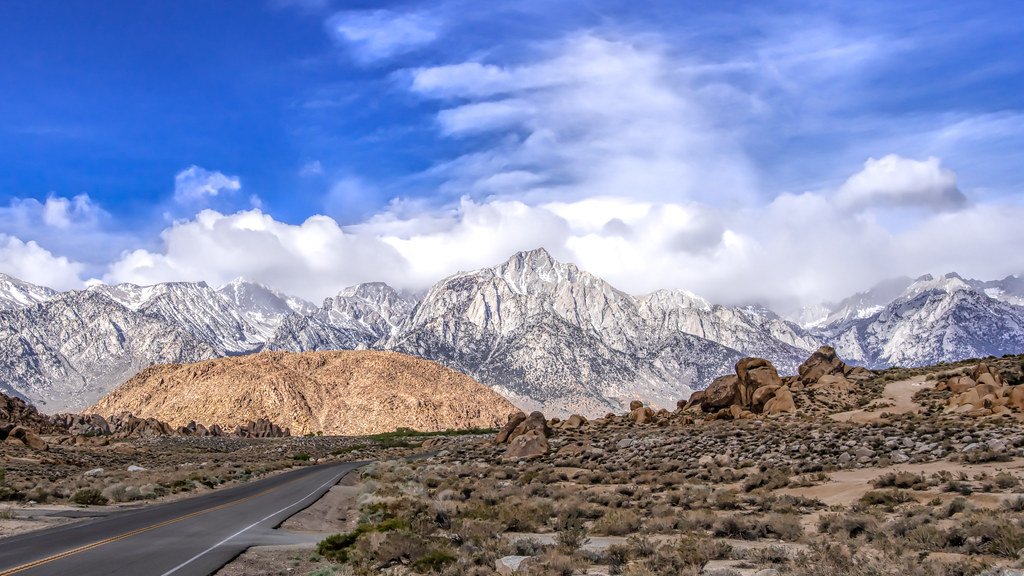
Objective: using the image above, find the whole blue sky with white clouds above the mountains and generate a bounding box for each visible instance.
[0,0,1024,307]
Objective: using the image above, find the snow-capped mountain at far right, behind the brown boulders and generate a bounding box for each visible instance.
[818,274,1024,368]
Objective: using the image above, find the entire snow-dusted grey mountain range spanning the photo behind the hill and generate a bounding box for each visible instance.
[0,249,1024,415]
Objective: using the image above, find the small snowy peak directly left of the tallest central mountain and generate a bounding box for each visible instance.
[266,282,416,352]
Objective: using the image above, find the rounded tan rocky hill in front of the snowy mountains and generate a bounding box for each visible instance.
[86,351,516,435]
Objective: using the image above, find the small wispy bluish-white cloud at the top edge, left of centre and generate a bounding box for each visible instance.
[328,9,442,64]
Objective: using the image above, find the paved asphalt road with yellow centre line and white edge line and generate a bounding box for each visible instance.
[0,457,362,576]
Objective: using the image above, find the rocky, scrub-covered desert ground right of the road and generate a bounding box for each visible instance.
[235,347,1024,576]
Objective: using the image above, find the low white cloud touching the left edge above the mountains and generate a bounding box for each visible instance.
[0,234,85,290]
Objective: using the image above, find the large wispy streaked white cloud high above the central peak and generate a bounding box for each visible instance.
[409,35,756,203]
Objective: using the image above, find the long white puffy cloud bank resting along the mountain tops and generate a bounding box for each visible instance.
[99,170,1024,307]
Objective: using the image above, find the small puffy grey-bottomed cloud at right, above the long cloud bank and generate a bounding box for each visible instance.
[836,154,967,210]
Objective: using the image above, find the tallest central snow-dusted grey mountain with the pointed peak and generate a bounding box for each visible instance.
[385,249,741,414]
